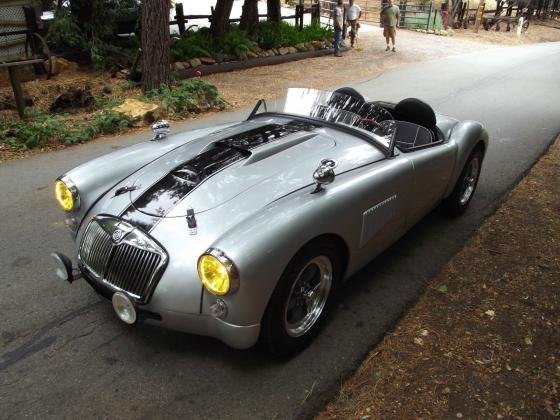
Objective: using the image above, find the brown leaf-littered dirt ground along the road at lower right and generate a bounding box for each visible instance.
[317,135,560,420]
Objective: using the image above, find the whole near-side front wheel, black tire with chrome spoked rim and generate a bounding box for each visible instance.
[261,242,340,356]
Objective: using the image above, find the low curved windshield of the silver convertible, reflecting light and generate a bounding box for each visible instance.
[248,88,395,157]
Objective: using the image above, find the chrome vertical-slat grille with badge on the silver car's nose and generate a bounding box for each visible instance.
[78,216,167,303]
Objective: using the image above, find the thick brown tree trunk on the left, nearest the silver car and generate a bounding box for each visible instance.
[142,0,170,92]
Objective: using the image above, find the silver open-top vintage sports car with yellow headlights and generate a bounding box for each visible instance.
[53,88,488,355]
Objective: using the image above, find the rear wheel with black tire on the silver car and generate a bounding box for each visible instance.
[444,146,484,216]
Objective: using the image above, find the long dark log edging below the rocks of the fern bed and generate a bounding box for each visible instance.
[171,47,349,80]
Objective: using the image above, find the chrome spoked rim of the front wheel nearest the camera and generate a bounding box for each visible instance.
[284,255,333,337]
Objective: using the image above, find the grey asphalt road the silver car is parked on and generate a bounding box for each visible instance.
[0,43,560,418]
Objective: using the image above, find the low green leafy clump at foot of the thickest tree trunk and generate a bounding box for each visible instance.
[146,78,227,117]
